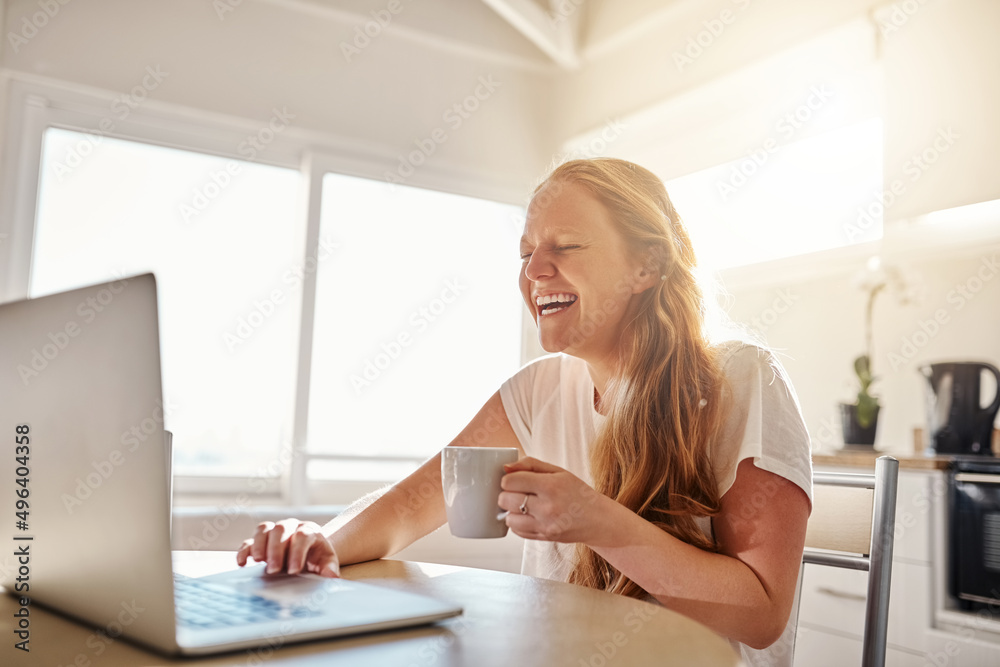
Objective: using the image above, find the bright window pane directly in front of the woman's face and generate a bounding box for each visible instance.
[308,174,523,477]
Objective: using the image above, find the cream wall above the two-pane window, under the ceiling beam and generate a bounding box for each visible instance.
[3,0,556,196]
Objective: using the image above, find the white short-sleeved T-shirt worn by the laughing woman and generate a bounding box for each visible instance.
[500,341,812,666]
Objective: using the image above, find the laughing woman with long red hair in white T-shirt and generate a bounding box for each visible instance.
[237,159,812,665]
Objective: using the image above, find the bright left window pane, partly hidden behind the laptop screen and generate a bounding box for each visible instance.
[31,128,305,474]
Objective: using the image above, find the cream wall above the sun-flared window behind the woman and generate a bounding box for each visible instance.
[557,0,878,144]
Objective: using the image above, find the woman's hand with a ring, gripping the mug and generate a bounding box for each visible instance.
[499,457,616,544]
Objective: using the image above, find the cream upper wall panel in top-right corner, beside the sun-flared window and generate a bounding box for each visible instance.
[884,0,1000,219]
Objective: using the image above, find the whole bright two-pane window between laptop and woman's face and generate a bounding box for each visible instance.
[30,127,523,483]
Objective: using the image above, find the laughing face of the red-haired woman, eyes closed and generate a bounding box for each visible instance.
[519,182,659,363]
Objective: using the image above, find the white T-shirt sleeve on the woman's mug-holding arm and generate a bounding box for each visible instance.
[713,343,812,504]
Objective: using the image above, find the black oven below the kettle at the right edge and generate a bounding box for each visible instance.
[949,457,1000,609]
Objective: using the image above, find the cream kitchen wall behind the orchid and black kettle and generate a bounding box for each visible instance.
[730,243,1000,454]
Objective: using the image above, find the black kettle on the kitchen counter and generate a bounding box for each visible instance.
[917,361,1000,456]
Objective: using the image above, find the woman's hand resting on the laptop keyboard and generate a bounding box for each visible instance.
[236,519,340,577]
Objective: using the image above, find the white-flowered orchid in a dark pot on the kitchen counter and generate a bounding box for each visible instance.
[840,257,910,445]
